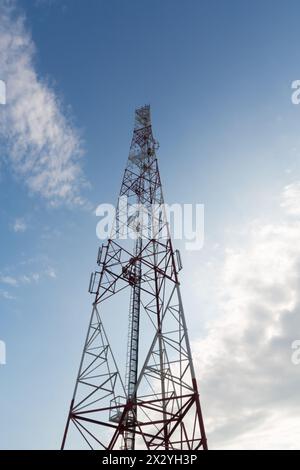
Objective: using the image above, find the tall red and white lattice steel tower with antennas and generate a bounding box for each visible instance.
[62,106,207,450]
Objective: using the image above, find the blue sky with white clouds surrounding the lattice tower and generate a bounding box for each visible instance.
[0,0,300,449]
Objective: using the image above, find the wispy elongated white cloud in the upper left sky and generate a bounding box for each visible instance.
[0,0,83,205]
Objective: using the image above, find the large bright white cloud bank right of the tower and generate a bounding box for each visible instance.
[193,184,300,448]
